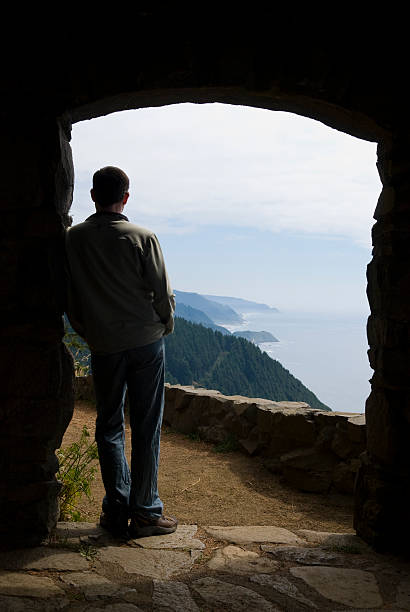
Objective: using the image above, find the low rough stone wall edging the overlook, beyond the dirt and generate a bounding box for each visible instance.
[76,377,366,494]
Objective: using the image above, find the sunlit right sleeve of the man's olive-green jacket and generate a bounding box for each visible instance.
[144,234,175,336]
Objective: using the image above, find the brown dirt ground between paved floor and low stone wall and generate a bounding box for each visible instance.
[62,402,353,532]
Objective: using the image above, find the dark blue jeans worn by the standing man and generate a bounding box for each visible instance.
[91,339,165,517]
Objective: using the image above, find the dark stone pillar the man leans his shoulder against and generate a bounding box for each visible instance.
[0,117,74,546]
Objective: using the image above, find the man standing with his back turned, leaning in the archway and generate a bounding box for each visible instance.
[66,166,178,537]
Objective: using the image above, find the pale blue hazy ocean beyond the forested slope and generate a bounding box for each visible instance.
[225,311,372,412]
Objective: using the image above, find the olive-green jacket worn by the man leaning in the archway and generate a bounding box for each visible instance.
[65,212,175,353]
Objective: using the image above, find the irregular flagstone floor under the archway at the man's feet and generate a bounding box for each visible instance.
[0,523,410,612]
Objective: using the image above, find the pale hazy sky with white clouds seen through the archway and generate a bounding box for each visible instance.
[72,104,381,313]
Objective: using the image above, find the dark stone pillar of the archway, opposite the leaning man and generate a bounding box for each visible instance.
[355,130,410,551]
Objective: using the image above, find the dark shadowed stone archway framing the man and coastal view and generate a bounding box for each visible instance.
[0,23,410,550]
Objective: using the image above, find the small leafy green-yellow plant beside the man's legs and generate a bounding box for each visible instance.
[56,425,98,521]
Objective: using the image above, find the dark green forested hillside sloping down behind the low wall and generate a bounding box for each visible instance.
[166,317,329,410]
